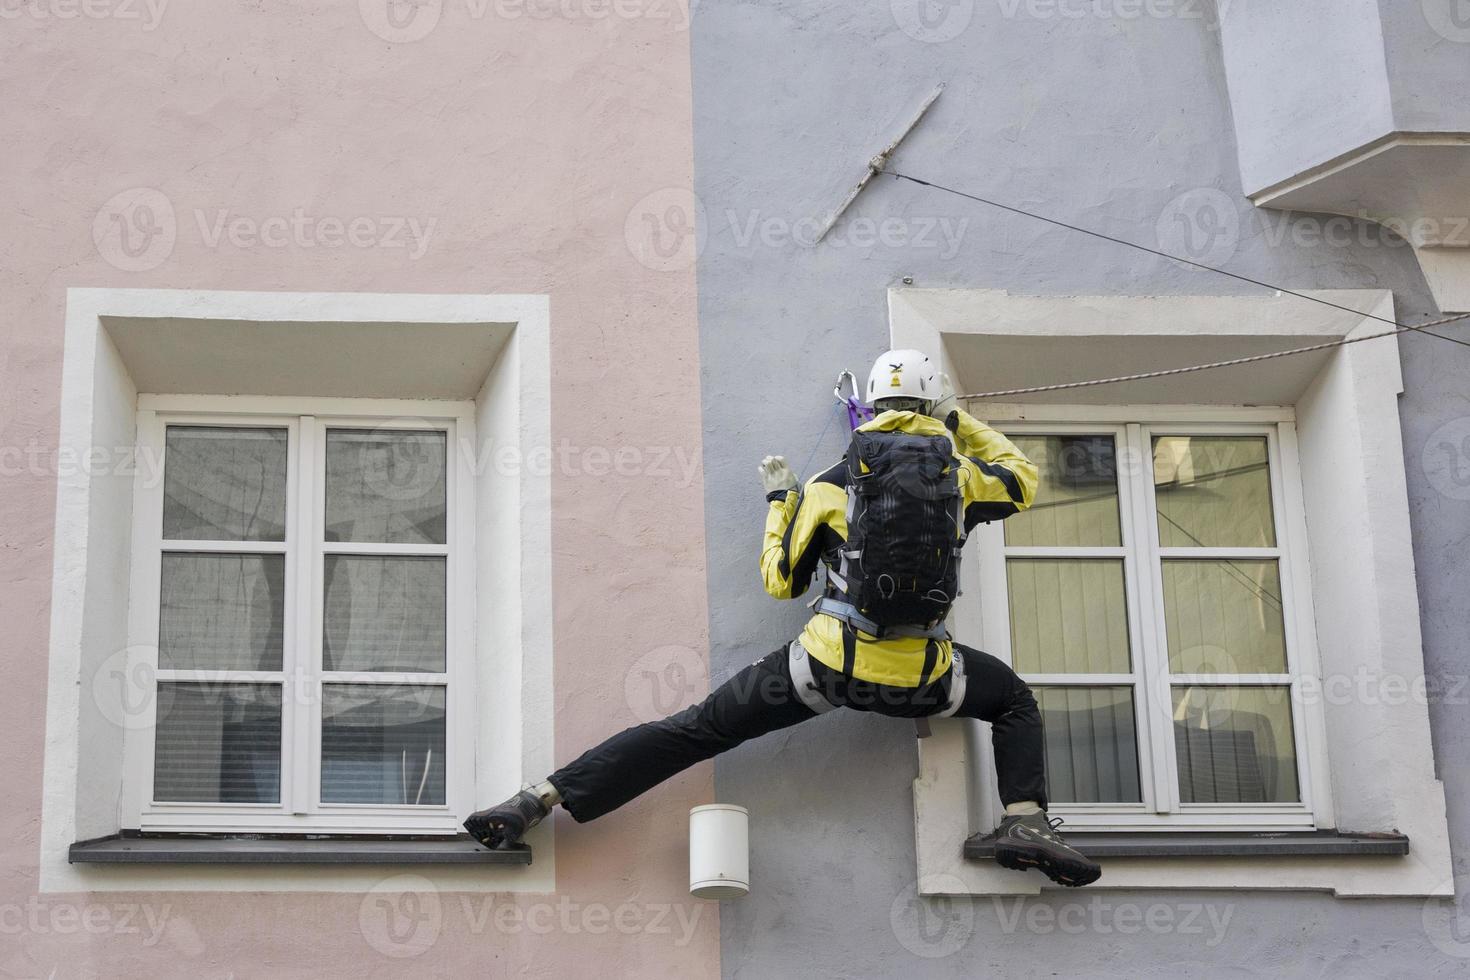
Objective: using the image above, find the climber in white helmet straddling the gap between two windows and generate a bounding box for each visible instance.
[465,350,1101,886]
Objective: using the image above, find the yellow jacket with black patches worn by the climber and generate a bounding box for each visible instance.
[760,411,1036,688]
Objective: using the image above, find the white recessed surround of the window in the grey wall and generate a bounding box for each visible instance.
[888,288,1452,896]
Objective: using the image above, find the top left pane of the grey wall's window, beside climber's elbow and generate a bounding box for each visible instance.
[1005,435,1123,548]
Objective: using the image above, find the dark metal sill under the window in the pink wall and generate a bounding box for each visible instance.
[66,830,531,865]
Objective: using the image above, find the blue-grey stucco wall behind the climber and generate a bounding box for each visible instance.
[692,0,1470,979]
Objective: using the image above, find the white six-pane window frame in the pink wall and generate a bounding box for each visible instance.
[123,395,476,833]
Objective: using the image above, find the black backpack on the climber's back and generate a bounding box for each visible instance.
[829,432,964,636]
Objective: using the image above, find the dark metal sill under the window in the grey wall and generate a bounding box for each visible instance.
[964,830,1408,861]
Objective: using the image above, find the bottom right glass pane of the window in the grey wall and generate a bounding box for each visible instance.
[1173,686,1301,804]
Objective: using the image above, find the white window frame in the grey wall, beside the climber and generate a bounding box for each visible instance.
[972,407,1330,832]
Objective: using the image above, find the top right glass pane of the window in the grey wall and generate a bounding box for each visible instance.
[1154,435,1276,548]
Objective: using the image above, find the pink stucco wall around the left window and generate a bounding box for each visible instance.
[0,0,719,977]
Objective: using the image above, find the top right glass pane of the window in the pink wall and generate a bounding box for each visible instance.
[326,429,448,545]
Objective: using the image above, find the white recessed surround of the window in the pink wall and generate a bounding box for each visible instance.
[40,289,556,892]
